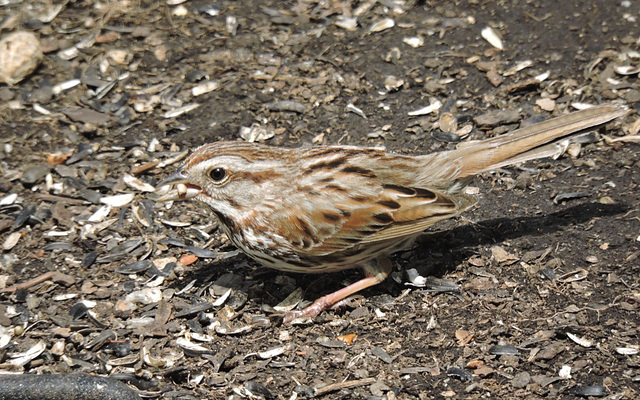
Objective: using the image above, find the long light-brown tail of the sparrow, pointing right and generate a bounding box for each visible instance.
[454,105,628,179]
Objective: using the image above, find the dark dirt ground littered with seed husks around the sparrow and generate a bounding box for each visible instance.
[0,0,640,399]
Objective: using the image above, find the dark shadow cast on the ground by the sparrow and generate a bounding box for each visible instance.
[178,203,629,305]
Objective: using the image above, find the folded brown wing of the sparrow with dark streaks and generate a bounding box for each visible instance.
[262,181,474,256]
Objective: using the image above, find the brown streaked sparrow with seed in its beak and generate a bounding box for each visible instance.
[158,105,626,321]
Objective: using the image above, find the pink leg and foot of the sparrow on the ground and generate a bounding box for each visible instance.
[284,256,392,323]
